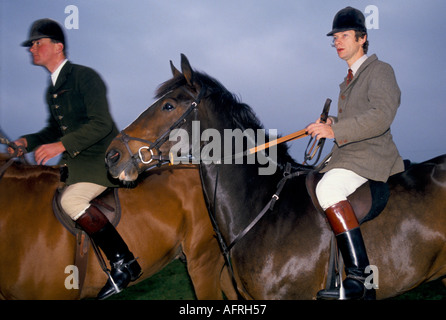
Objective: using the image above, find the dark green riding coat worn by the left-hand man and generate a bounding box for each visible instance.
[24,61,118,187]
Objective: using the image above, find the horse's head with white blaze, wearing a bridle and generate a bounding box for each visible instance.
[106,55,206,183]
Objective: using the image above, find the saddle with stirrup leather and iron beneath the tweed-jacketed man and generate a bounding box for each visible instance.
[305,170,390,298]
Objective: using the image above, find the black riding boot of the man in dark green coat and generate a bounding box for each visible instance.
[76,206,141,300]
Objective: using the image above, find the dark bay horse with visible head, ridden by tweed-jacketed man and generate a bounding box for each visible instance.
[106,55,446,299]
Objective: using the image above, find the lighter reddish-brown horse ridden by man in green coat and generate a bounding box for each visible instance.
[0,154,235,300]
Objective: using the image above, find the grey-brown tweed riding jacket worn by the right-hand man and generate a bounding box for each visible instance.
[321,55,404,182]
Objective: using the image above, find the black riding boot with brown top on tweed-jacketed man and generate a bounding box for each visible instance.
[317,201,376,300]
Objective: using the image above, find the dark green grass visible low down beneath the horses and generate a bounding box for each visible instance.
[109,260,446,300]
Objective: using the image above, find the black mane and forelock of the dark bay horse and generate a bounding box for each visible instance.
[155,71,299,166]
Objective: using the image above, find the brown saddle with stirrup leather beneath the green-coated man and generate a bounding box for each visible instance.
[53,186,121,295]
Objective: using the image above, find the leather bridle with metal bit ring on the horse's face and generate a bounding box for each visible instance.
[115,86,206,172]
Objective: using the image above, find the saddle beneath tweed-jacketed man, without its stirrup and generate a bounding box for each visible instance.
[305,171,390,223]
